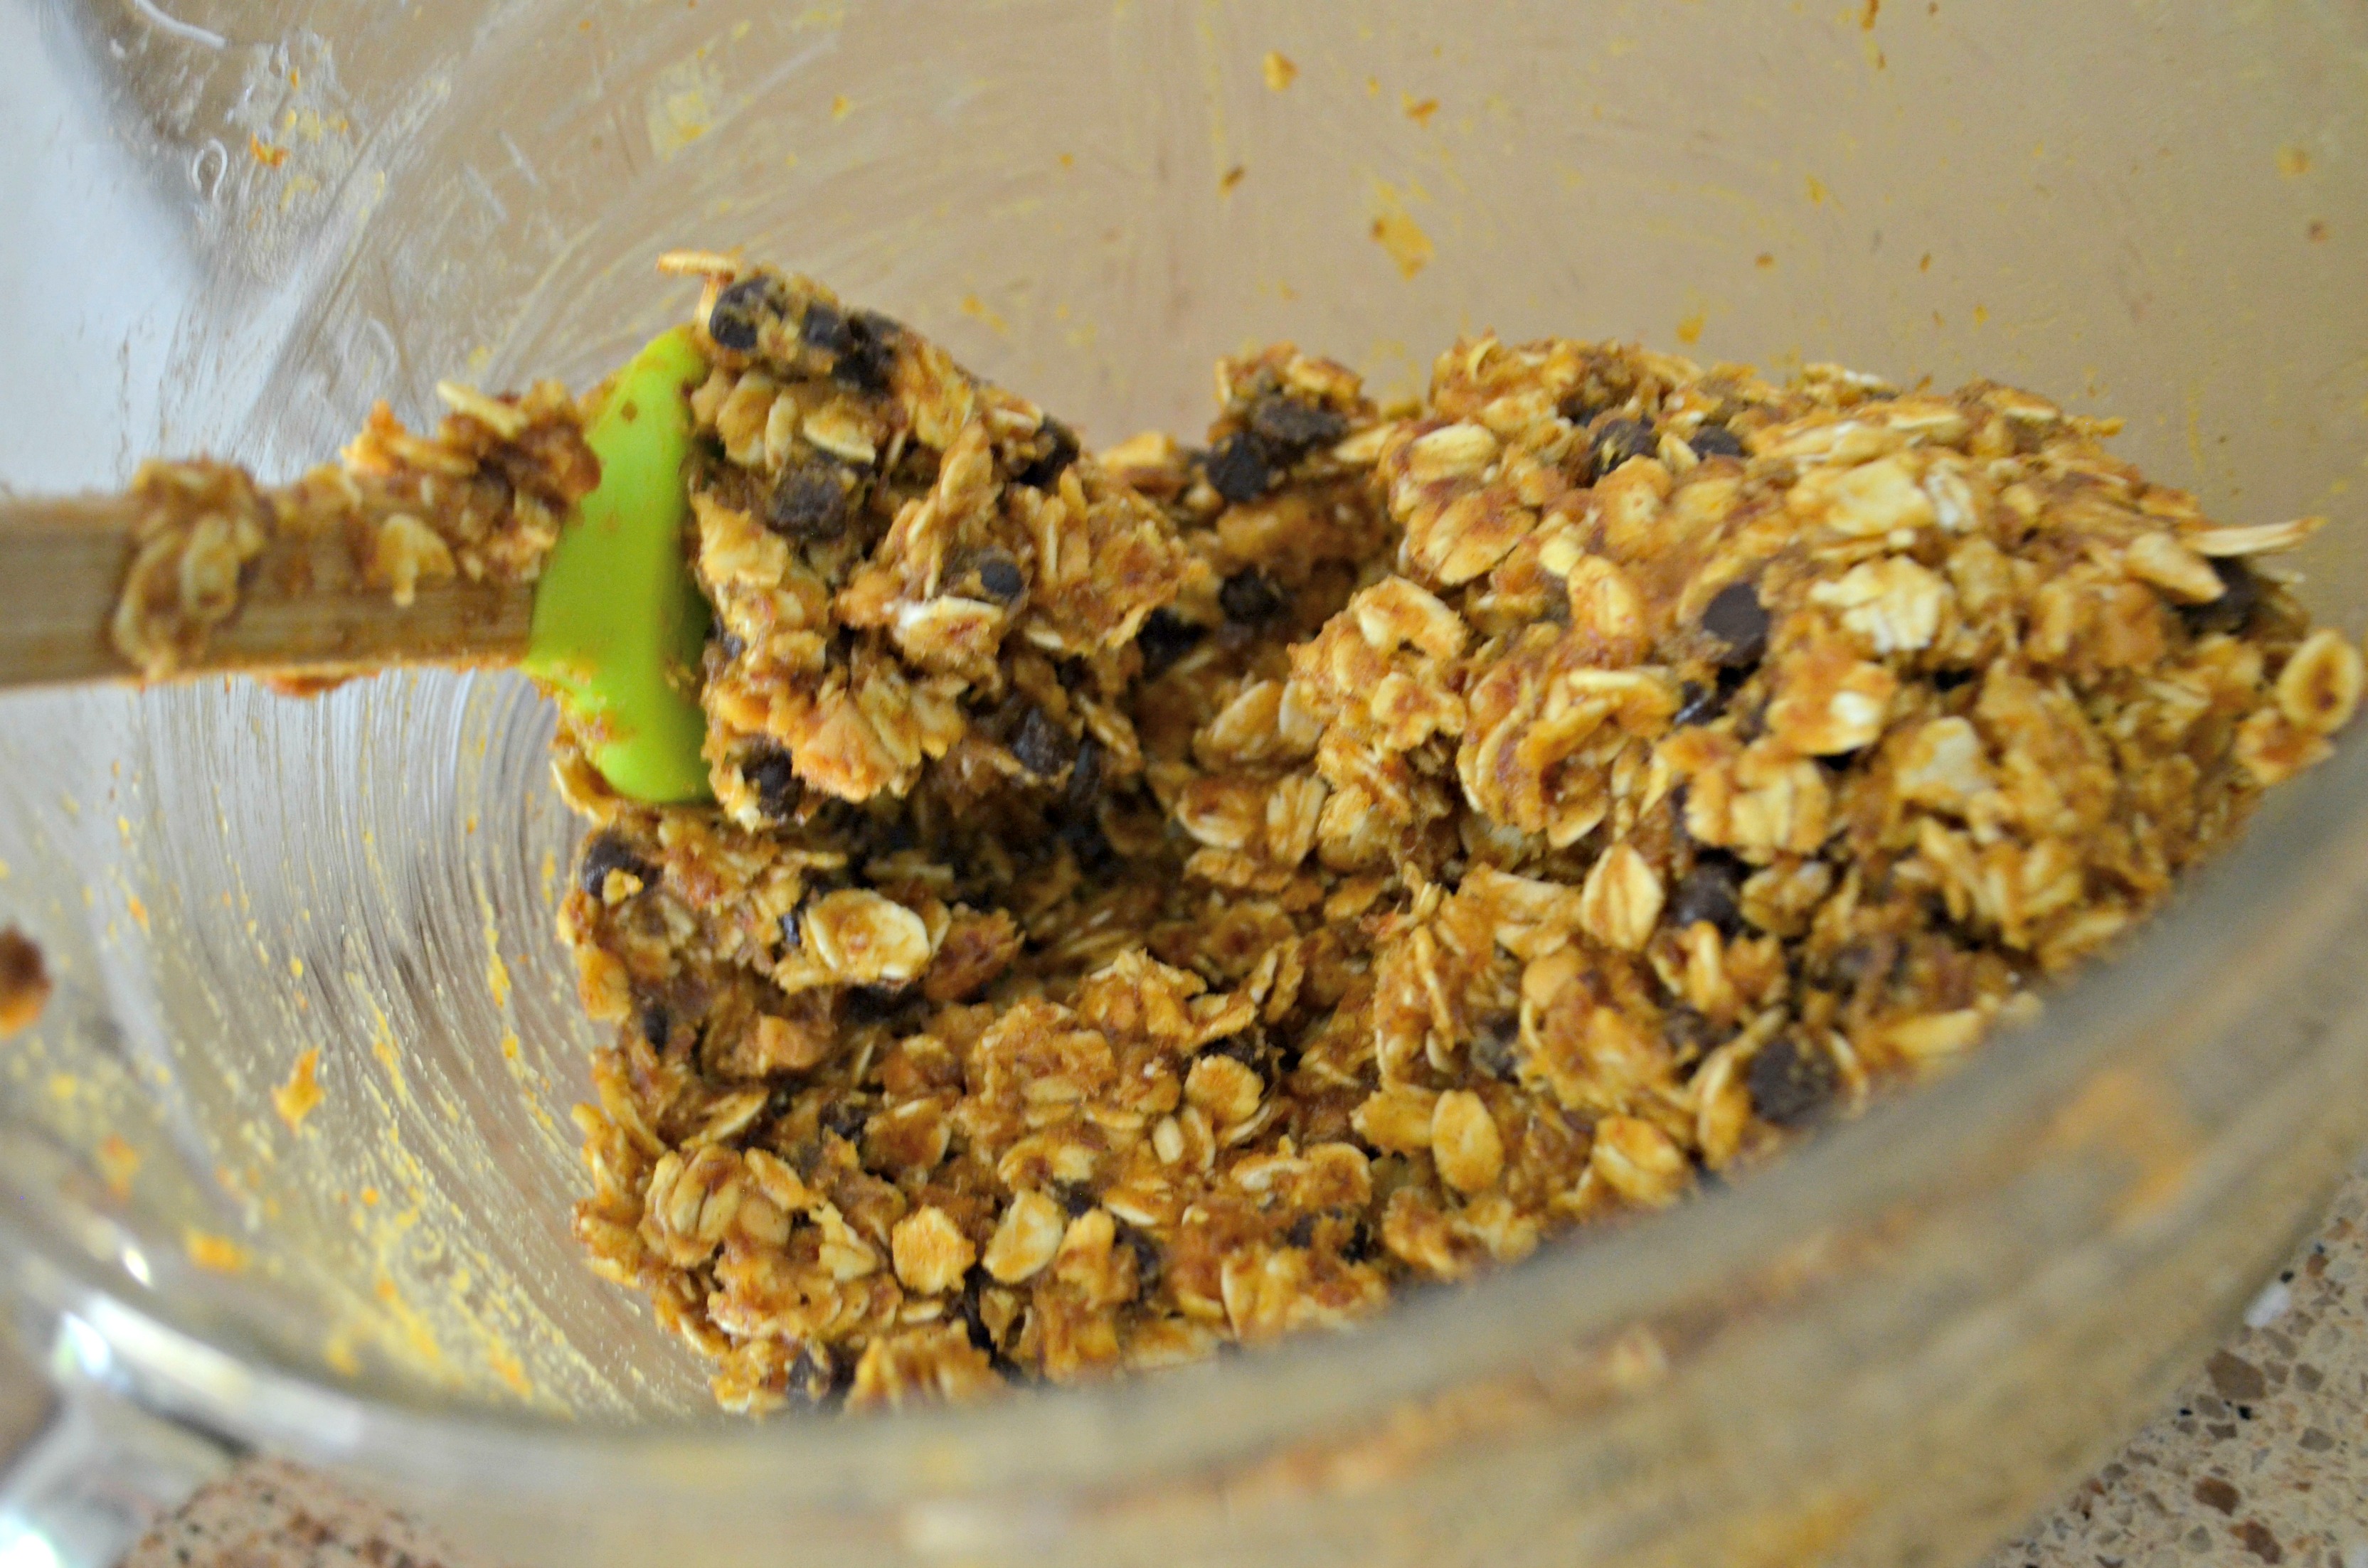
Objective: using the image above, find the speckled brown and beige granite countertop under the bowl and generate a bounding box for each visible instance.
[106,1170,2368,1568]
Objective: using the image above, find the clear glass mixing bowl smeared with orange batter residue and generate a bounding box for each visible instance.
[0,0,2368,1566]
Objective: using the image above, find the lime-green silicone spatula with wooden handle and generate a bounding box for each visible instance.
[0,327,708,803]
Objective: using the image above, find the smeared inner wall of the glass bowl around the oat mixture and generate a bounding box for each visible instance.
[0,0,2368,1417]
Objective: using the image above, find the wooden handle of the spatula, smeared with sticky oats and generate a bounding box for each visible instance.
[0,490,535,687]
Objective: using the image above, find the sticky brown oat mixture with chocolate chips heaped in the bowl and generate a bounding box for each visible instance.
[556,256,2361,1412]
